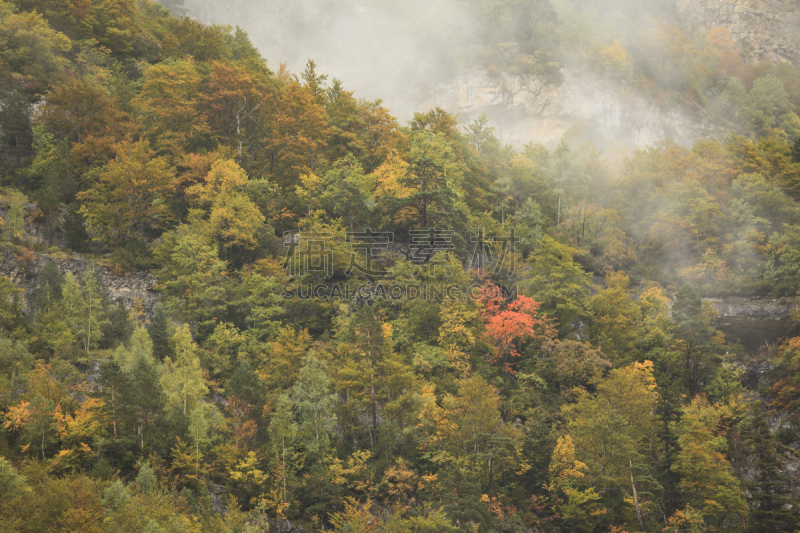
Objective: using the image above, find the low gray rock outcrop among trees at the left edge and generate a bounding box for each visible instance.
[0,248,158,314]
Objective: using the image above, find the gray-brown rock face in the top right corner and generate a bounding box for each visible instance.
[677,0,800,65]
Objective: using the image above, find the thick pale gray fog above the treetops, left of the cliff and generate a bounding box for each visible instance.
[177,0,490,118]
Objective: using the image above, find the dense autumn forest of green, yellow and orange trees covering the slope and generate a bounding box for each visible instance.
[0,0,800,533]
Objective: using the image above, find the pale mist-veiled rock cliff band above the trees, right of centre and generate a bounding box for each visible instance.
[423,69,711,149]
